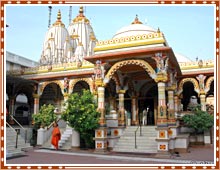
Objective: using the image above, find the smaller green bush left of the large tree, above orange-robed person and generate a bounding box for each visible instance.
[32,104,57,129]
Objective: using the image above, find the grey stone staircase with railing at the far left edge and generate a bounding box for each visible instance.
[6,127,33,158]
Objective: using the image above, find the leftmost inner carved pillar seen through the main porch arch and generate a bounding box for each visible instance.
[118,90,125,126]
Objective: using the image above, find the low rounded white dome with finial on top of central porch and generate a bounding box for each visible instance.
[113,15,157,39]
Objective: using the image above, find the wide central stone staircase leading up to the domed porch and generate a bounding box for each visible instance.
[113,126,157,154]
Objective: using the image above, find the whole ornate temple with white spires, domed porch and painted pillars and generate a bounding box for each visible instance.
[6,7,214,154]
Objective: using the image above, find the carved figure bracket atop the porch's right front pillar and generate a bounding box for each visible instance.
[152,53,169,73]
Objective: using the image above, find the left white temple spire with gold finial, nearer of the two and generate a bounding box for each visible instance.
[40,10,71,65]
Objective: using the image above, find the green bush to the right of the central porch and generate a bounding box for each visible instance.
[182,105,214,133]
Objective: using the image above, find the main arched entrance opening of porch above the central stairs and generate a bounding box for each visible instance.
[106,60,158,126]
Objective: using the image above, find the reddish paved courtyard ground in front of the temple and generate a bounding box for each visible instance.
[6,146,214,166]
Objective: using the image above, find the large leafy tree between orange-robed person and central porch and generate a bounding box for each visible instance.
[61,90,100,148]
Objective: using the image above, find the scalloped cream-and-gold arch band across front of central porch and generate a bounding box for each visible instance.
[104,60,156,83]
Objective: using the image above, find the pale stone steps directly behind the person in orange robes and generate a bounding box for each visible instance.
[42,127,72,150]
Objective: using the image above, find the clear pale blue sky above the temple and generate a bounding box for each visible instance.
[5,4,215,61]
